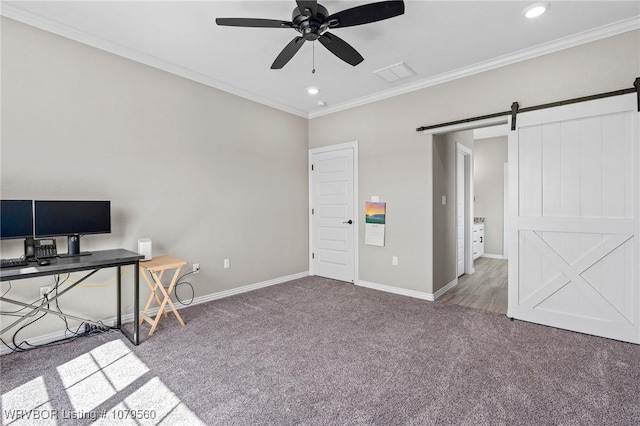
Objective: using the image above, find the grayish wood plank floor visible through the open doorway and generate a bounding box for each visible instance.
[438,257,507,315]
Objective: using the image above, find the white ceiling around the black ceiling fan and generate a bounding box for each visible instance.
[1,0,640,118]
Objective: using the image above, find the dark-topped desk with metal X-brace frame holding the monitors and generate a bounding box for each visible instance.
[0,249,144,345]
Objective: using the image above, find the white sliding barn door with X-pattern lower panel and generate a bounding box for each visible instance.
[508,94,640,343]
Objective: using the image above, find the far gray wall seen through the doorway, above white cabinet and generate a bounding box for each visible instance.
[473,136,507,256]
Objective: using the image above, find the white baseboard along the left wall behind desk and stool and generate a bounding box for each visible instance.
[0,271,309,355]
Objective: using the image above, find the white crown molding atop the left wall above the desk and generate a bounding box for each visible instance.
[0,3,309,118]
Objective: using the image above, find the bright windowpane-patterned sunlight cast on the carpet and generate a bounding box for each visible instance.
[0,340,204,426]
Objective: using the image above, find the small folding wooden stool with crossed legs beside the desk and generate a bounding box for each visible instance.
[140,256,187,336]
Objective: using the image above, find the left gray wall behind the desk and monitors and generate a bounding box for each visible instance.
[0,18,308,335]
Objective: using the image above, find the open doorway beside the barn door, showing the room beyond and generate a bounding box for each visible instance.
[433,118,508,314]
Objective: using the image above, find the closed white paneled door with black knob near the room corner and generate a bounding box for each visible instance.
[310,144,358,282]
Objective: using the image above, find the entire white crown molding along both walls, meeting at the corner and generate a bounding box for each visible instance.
[0,3,640,119]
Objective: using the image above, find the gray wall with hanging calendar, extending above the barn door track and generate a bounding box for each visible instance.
[309,31,640,294]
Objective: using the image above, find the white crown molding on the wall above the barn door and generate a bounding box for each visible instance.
[309,16,640,119]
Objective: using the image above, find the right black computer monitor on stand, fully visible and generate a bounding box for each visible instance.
[34,200,111,255]
